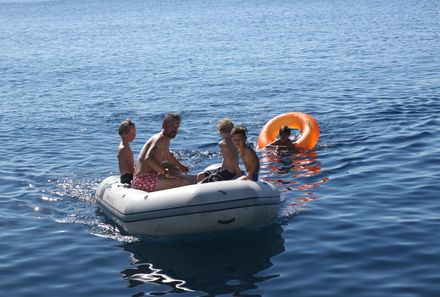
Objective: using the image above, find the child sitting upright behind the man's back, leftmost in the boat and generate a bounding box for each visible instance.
[118,119,136,184]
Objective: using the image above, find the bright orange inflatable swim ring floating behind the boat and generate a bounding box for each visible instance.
[258,112,319,150]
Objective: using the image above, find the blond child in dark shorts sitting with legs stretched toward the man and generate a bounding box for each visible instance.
[197,118,242,183]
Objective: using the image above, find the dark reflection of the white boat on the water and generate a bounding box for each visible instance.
[122,224,284,296]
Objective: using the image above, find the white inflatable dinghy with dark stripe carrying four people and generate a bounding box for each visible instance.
[96,176,282,236]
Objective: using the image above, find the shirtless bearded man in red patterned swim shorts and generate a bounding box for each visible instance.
[131,113,190,192]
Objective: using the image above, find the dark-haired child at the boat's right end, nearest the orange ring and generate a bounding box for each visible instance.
[231,126,260,181]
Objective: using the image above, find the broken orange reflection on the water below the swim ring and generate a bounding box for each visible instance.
[261,150,329,216]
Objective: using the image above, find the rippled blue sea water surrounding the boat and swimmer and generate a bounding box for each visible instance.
[0,0,440,297]
